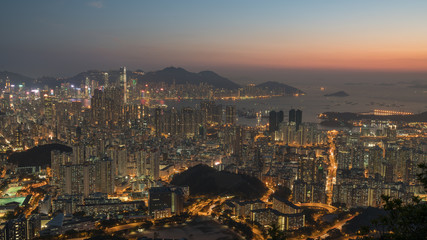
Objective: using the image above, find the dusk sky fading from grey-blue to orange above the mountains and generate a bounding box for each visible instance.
[0,0,427,76]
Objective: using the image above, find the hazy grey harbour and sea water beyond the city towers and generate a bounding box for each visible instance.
[165,79,427,125]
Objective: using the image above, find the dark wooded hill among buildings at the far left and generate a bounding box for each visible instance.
[8,143,72,167]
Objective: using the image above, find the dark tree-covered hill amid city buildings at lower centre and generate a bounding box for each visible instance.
[171,164,267,199]
